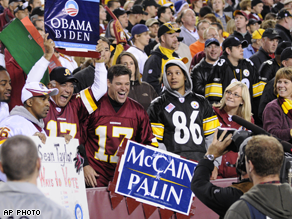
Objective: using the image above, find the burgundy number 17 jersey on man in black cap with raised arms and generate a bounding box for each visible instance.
[44,88,96,143]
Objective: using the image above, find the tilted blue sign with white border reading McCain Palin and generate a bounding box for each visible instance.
[115,140,197,215]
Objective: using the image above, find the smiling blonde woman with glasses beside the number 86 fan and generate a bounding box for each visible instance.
[213,81,254,178]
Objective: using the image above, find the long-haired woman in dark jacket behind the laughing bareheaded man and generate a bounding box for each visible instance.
[116,52,158,110]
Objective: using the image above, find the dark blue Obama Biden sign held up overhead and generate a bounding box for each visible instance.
[44,0,99,51]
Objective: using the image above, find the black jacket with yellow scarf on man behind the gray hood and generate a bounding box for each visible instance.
[142,47,179,95]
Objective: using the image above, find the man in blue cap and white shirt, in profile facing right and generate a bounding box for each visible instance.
[127,24,150,74]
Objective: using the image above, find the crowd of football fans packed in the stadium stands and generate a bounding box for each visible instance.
[0,0,292,217]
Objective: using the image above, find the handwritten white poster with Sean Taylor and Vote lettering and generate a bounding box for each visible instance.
[31,137,89,219]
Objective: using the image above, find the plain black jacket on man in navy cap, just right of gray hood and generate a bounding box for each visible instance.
[191,58,213,96]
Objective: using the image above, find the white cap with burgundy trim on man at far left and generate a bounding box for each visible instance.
[21,82,59,103]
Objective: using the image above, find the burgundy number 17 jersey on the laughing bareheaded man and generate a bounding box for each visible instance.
[85,94,158,186]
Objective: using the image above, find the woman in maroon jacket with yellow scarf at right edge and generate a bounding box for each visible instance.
[263,67,292,143]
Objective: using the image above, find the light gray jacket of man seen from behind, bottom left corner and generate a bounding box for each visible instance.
[0,182,73,219]
